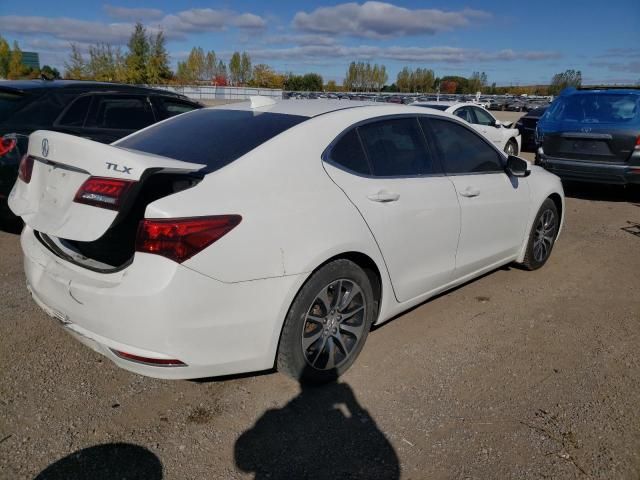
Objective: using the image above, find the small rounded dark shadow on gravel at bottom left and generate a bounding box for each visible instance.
[35,443,162,480]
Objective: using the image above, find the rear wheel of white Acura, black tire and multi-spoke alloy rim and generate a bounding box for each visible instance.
[276,259,378,383]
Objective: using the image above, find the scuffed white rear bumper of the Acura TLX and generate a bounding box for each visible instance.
[21,227,302,379]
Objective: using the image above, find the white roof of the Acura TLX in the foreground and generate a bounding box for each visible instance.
[211,99,381,118]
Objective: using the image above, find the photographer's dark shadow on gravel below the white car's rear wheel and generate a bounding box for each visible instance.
[234,366,400,480]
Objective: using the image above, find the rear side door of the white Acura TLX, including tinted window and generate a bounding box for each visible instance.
[324,116,460,302]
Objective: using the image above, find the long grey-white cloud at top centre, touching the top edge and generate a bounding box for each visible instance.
[293,1,491,38]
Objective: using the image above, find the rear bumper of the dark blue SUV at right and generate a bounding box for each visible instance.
[536,149,640,185]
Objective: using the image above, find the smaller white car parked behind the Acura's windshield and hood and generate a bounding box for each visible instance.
[412,102,522,155]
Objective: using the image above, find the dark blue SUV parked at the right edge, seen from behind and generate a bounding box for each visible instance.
[536,88,640,184]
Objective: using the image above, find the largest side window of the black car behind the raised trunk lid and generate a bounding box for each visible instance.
[86,95,155,130]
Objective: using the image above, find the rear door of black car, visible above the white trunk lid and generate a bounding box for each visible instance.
[80,94,156,143]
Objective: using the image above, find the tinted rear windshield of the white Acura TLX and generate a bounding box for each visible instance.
[117,109,307,172]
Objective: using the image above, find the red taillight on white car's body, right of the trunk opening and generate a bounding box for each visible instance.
[136,215,242,263]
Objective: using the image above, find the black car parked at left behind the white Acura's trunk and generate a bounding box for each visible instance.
[0,80,202,219]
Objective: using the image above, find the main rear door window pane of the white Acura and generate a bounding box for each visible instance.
[358,118,434,177]
